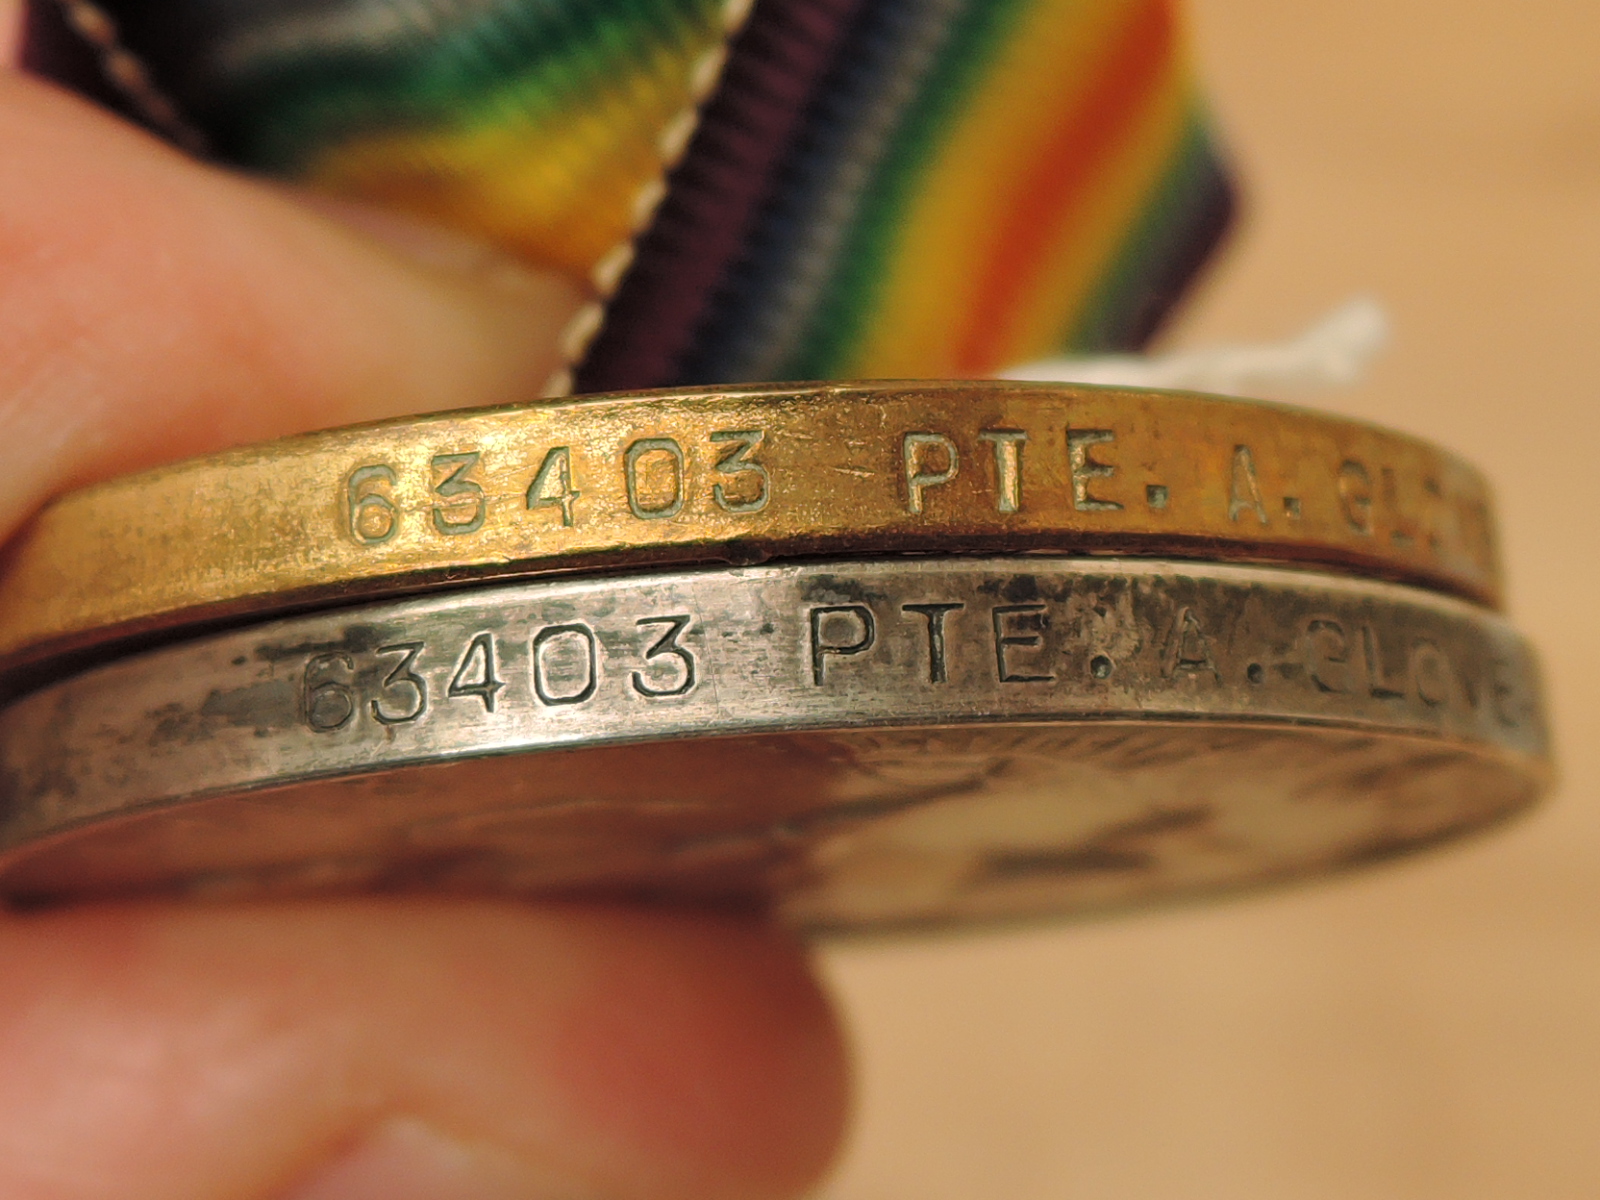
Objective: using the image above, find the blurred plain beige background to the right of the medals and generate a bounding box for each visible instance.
[826,0,1600,1200]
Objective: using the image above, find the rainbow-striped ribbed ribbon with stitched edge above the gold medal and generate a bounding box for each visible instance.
[34,0,1232,390]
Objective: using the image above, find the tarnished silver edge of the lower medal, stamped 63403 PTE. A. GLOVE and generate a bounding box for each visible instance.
[0,557,1547,848]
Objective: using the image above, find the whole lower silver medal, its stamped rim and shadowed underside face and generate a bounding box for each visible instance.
[0,558,1547,930]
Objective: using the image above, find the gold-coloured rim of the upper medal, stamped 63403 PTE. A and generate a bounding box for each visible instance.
[0,381,1501,672]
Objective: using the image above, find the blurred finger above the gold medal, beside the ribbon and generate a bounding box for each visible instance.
[0,65,579,534]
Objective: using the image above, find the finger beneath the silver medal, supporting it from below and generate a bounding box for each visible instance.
[0,901,845,1200]
